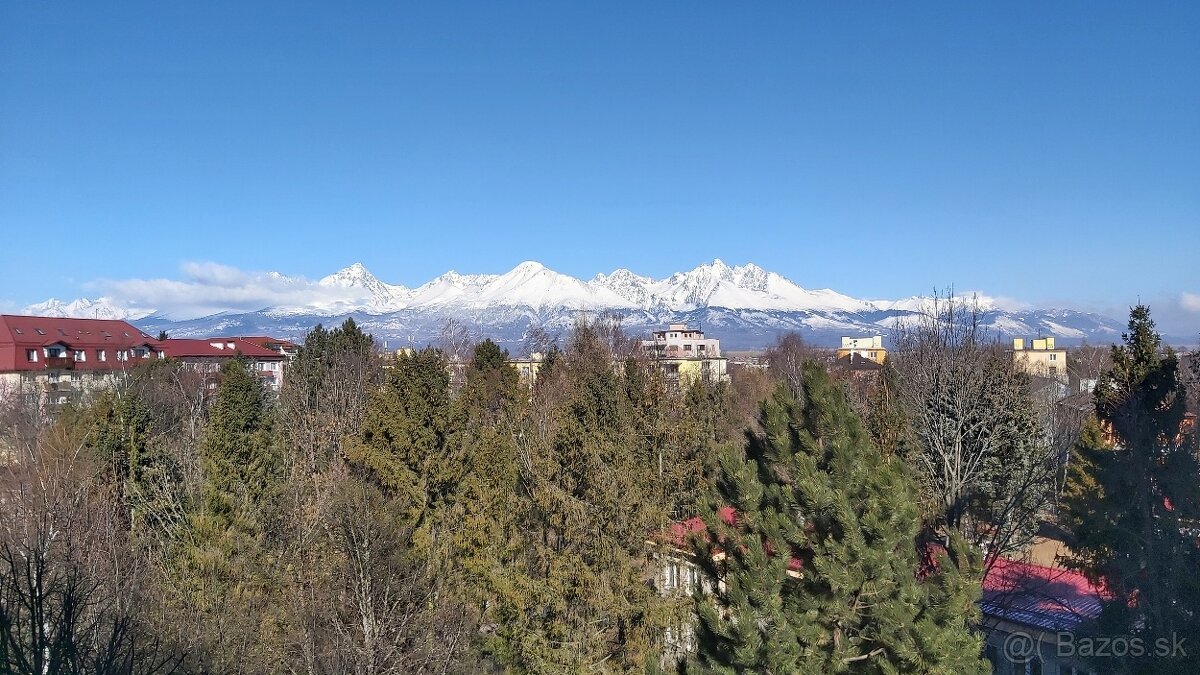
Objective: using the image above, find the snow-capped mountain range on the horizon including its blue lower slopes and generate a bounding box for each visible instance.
[25,259,1122,348]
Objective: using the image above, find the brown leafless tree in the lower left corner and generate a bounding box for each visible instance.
[0,426,182,675]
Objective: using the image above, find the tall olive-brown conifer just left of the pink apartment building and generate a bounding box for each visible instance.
[488,323,666,674]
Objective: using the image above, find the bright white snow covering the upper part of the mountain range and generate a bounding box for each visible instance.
[18,258,1089,330]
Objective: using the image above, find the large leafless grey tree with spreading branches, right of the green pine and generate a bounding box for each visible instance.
[893,292,1054,566]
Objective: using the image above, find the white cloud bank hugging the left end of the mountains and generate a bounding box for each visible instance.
[85,262,364,319]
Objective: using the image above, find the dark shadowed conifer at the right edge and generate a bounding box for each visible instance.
[1064,305,1200,673]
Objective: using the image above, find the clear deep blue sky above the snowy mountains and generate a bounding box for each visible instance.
[0,2,1200,333]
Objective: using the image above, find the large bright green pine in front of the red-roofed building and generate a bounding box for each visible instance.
[688,362,988,675]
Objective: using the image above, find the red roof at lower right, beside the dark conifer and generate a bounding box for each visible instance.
[980,558,1106,631]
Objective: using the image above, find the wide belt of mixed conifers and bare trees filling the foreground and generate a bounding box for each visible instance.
[0,302,1200,675]
